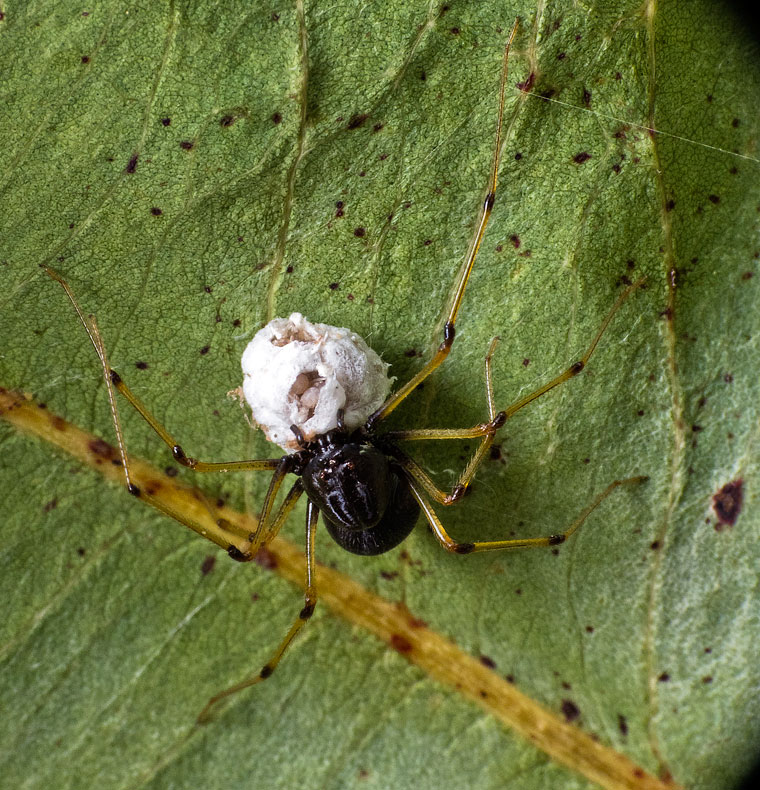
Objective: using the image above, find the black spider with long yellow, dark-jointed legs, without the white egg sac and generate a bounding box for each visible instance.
[43,22,645,722]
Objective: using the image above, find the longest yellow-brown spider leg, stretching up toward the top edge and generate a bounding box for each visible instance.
[365,20,517,430]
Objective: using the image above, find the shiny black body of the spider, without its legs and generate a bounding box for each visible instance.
[293,430,420,556]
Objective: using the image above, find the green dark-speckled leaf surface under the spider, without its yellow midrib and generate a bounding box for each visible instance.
[0,0,760,790]
